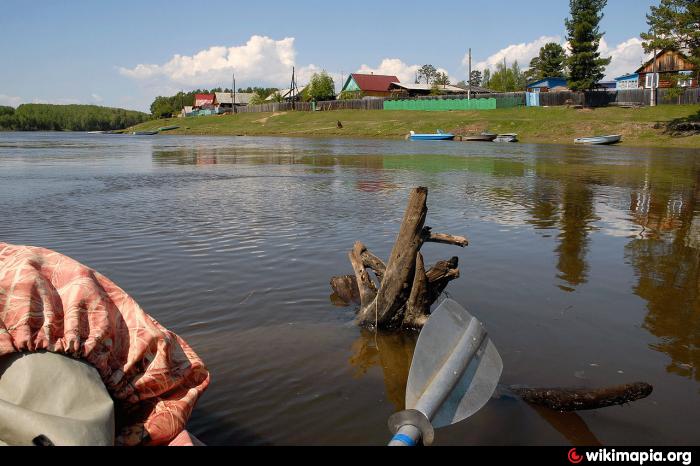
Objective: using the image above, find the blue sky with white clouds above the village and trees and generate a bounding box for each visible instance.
[0,0,658,111]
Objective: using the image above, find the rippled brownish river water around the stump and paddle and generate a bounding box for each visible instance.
[0,133,700,445]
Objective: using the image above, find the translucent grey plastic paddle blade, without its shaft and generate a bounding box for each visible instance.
[406,299,503,428]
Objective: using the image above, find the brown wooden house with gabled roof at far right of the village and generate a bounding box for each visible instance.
[636,50,698,89]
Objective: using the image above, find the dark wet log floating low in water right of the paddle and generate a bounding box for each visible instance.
[511,382,654,411]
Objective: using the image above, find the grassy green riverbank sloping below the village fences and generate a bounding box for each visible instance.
[128,105,700,148]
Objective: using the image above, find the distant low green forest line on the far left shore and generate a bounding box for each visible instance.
[0,104,149,131]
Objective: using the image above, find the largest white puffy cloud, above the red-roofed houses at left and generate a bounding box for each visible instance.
[119,35,318,88]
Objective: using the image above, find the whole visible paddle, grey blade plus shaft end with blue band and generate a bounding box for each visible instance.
[389,299,503,446]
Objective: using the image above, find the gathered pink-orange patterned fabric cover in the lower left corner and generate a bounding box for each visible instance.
[0,242,210,445]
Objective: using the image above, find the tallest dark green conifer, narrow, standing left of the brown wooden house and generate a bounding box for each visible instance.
[565,0,611,91]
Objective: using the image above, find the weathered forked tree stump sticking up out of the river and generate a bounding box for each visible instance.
[331,187,469,329]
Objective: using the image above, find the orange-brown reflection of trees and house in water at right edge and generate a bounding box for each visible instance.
[625,175,700,381]
